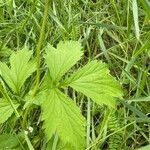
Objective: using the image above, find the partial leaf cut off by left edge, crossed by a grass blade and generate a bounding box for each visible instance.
[0,99,19,124]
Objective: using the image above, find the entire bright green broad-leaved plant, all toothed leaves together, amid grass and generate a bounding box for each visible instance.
[0,41,122,149]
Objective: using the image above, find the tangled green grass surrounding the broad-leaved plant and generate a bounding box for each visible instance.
[0,0,150,150]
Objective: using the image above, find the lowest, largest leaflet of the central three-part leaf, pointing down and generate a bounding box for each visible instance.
[42,89,85,150]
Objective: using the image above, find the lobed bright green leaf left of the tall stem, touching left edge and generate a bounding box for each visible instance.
[0,48,36,93]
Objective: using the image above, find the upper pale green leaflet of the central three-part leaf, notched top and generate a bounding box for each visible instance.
[45,41,83,83]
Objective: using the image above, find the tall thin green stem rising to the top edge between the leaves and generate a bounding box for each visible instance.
[34,0,51,94]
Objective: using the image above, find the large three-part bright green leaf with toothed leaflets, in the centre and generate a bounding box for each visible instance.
[41,41,122,150]
